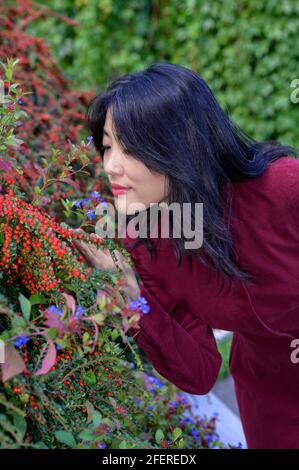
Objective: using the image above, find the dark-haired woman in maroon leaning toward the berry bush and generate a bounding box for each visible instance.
[74,62,299,448]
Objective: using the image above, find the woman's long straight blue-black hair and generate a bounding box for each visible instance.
[86,62,296,280]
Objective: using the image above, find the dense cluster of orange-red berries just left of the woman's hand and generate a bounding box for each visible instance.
[0,189,103,293]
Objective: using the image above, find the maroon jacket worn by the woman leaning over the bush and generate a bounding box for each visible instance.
[122,156,299,448]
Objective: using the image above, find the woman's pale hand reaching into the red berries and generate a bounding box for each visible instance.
[74,228,140,298]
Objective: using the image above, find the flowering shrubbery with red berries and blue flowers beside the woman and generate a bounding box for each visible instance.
[0,2,230,448]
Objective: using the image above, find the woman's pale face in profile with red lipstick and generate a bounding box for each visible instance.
[102,109,167,214]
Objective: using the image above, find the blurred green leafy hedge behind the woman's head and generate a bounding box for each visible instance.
[25,0,299,149]
